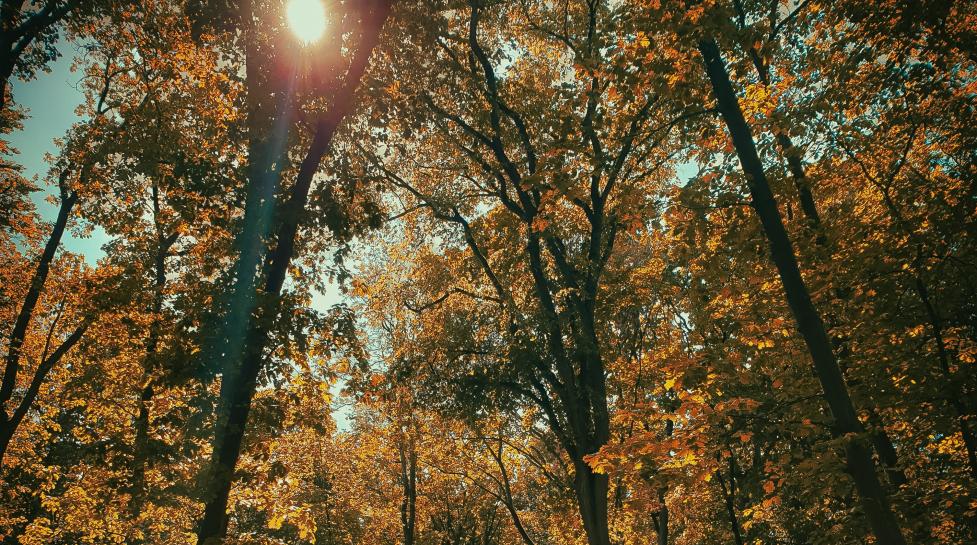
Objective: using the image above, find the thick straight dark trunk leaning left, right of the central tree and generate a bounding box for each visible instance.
[699,38,906,545]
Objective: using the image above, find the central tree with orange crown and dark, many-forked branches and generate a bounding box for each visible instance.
[350,2,701,544]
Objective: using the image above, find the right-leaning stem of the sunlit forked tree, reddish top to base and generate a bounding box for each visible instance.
[197,4,390,545]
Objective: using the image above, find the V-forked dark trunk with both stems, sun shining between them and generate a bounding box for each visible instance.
[197,1,390,544]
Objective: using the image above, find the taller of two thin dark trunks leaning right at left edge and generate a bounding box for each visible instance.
[0,178,78,465]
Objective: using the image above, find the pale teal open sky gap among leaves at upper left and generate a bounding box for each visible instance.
[8,43,109,265]
